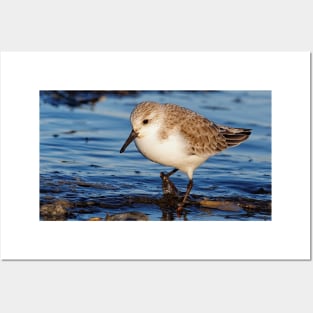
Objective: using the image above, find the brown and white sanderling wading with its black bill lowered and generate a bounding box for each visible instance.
[120,101,251,209]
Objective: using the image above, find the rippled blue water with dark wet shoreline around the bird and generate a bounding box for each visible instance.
[40,91,271,221]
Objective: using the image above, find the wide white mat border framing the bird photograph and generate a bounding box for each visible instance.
[1,52,310,259]
